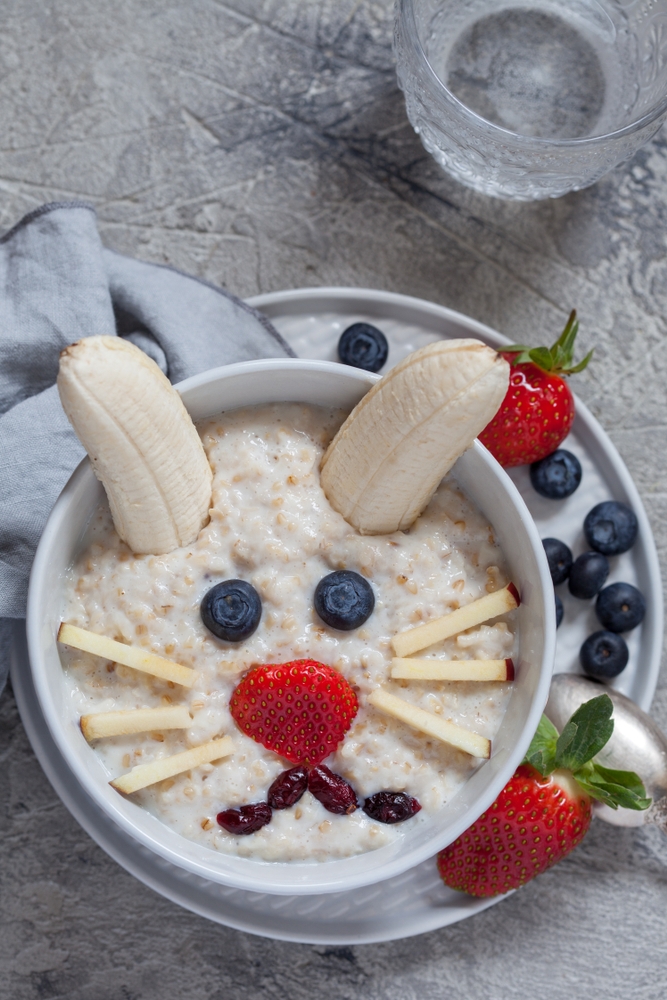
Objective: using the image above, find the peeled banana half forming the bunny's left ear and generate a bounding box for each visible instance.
[58,337,212,555]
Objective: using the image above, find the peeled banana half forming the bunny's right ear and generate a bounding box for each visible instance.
[321,340,509,535]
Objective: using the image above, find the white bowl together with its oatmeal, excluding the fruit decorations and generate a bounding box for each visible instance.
[27,359,555,894]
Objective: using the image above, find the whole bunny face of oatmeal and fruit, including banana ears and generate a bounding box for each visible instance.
[58,337,519,861]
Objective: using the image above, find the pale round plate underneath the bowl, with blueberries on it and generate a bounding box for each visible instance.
[12,288,662,945]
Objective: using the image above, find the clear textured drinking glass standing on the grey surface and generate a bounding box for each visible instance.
[394,0,667,200]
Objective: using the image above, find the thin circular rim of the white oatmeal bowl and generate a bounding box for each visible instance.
[26,358,556,895]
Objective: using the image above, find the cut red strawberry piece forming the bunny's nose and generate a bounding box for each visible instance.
[229,660,359,767]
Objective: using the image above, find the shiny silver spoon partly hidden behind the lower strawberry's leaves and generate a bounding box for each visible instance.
[544,674,667,833]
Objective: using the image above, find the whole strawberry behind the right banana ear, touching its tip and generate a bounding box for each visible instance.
[479,309,593,468]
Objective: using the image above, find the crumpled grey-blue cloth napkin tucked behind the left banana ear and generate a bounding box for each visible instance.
[0,202,294,691]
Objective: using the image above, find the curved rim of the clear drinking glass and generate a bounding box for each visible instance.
[397,0,667,149]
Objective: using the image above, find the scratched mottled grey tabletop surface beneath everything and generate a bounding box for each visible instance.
[0,0,667,1000]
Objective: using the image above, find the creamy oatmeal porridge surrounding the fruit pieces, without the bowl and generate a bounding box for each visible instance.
[61,403,514,861]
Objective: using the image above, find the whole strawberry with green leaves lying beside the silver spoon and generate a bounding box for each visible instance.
[438,694,651,896]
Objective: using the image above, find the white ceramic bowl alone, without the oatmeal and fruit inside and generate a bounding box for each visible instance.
[27,359,555,894]
